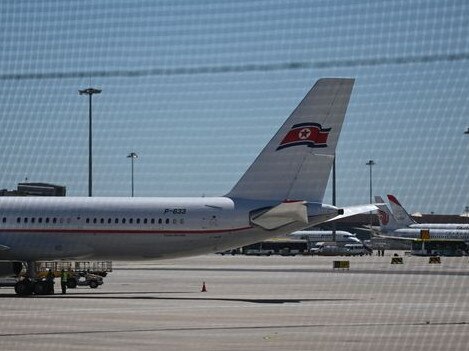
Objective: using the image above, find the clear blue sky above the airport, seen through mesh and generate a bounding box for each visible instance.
[0,0,469,214]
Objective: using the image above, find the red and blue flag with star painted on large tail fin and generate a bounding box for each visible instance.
[277,123,331,150]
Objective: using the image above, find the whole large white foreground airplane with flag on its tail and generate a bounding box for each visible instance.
[0,78,376,295]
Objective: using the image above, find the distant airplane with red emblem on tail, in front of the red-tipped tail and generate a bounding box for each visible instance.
[375,196,469,245]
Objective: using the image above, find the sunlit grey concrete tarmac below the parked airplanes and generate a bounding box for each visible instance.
[0,252,469,351]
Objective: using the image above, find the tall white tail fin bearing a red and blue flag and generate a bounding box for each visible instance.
[226,78,354,203]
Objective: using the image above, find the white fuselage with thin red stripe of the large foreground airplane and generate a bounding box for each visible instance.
[0,197,337,261]
